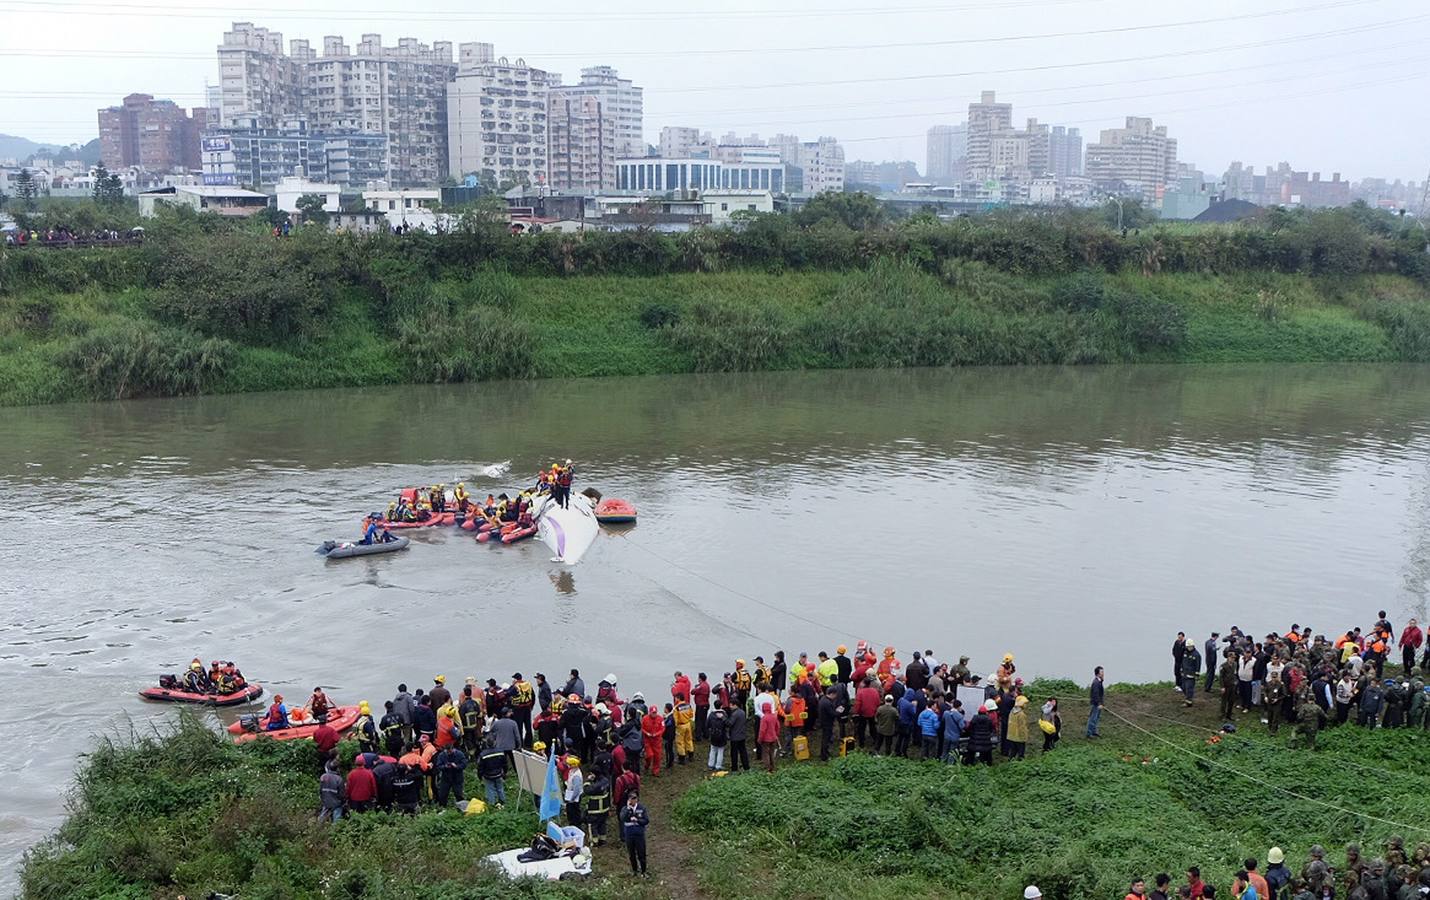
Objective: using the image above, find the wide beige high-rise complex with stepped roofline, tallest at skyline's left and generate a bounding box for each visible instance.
[219,21,456,185]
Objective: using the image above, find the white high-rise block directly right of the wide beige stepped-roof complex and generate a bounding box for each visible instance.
[448,43,561,185]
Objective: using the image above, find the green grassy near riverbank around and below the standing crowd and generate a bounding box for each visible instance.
[23,681,1430,900]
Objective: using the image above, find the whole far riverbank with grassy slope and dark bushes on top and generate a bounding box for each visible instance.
[0,210,1430,405]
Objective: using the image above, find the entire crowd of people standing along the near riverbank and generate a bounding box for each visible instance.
[290,603,1430,900]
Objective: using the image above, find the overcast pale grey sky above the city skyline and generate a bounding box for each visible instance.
[0,0,1430,180]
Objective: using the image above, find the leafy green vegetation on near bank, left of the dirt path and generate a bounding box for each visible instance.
[20,717,595,900]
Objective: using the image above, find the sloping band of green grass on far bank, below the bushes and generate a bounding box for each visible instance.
[0,259,1430,405]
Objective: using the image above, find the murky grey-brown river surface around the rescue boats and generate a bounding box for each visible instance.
[0,365,1430,893]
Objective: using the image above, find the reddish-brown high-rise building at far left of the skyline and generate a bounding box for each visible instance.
[99,94,212,172]
